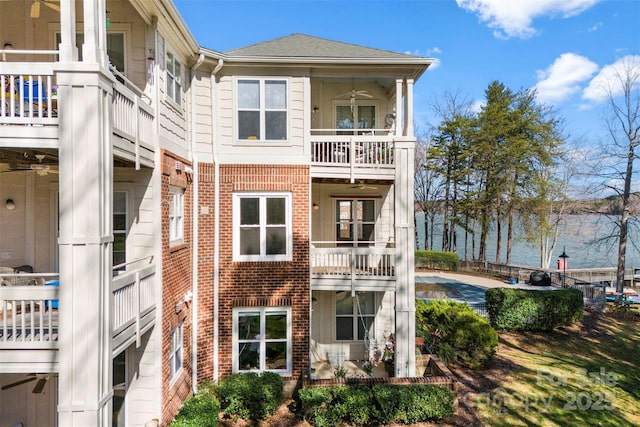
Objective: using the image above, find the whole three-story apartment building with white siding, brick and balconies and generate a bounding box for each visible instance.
[0,0,430,427]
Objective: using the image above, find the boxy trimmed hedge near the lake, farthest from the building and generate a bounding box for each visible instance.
[485,288,584,331]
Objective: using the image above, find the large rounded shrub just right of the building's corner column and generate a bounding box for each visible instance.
[416,300,498,368]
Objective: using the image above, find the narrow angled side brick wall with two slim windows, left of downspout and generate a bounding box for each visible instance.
[161,150,193,426]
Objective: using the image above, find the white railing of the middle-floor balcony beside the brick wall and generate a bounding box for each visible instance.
[310,241,396,292]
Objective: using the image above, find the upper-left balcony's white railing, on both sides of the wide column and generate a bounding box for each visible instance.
[0,62,155,167]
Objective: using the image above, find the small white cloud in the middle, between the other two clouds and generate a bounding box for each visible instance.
[535,53,598,102]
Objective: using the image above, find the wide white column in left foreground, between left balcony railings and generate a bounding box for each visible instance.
[57,64,113,427]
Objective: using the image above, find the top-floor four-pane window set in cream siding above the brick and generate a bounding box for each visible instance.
[237,79,287,141]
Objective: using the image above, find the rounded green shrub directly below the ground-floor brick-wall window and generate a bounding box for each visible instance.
[216,372,284,420]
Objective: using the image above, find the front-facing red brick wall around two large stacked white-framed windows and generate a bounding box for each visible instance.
[215,165,310,380]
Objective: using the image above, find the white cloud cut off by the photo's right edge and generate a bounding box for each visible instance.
[582,55,640,102]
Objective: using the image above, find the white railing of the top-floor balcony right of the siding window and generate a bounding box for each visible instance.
[311,129,395,182]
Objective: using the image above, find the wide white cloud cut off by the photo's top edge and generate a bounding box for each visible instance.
[456,0,602,39]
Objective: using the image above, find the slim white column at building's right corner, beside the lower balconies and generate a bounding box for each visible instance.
[394,138,416,377]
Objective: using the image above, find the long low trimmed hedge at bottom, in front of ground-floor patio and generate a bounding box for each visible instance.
[298,384,454,427]
